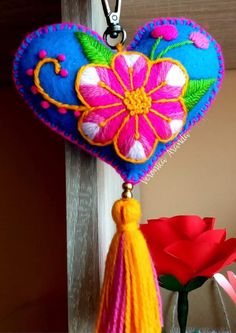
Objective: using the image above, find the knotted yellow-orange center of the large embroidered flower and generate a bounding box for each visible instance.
[123,87,152,116]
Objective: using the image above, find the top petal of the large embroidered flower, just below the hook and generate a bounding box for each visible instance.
[113,52,148,90]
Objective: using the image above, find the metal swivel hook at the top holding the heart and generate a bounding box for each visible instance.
[102,0,126,49]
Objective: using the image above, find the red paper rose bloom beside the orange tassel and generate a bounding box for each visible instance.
[141,216,236,285]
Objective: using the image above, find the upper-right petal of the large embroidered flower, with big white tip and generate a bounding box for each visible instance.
[145,60,188,100]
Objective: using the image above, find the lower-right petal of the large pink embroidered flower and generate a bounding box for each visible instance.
[147,101,185,141]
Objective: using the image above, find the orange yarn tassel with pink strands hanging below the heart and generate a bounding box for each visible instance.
[96,198,161,333]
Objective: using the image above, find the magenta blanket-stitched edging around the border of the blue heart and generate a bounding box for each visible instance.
[13,18,224,185]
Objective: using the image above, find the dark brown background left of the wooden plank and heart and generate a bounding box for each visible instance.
[0,0,67,332]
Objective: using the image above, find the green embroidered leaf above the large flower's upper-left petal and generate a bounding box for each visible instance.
[75,32,114,65]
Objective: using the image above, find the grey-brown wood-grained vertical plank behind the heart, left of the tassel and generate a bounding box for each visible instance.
[62,0,99,333]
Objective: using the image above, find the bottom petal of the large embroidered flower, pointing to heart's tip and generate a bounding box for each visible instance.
[114,115,157,162]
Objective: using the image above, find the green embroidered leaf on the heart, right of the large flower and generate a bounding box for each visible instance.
[184,79,216,111]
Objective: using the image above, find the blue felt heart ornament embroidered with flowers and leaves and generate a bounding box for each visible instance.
[13,18,224,184]
